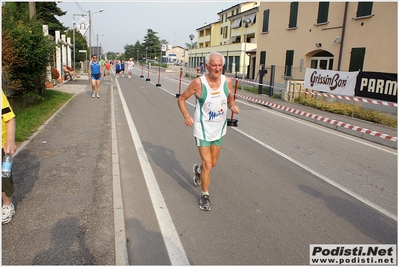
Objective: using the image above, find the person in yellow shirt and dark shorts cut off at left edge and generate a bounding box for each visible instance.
[1,90,17,224]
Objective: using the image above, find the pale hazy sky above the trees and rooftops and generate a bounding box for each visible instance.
[57,0,241,53]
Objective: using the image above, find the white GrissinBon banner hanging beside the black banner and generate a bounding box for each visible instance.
[305,68,359,96]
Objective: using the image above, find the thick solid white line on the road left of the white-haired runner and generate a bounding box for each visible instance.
[116,80,190,265]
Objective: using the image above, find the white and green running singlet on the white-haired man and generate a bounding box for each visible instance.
[194,75,229,141]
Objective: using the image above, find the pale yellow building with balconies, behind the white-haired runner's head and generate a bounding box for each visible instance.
[188,1,259,75]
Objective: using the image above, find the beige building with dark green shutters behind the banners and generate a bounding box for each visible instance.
[255,2,398,87]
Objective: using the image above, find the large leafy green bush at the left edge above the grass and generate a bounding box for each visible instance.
[2,2,55,96]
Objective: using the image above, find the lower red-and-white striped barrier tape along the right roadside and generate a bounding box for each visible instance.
[236,94,398,142]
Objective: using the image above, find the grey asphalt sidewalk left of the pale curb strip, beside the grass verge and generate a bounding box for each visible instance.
[2,76,115,265]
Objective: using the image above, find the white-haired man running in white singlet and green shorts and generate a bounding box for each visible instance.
[178,52,240,210]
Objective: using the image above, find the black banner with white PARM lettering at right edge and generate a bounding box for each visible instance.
[355,71,398,103]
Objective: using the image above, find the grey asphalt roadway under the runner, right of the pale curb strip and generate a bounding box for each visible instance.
[114,71,397,265]
